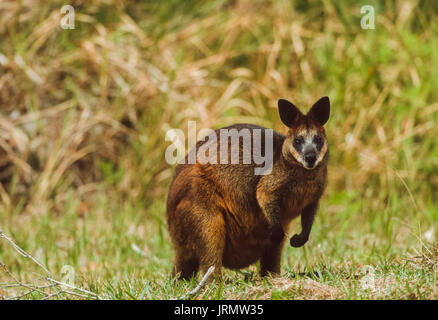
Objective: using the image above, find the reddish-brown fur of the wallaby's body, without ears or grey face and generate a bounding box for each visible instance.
[167,99,328,279]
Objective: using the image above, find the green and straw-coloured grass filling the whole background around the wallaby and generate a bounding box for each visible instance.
[0,0,438,299]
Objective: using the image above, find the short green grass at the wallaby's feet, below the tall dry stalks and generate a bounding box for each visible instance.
[1,188,437,299]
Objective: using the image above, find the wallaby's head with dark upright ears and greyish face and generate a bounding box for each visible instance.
[278,97,330,170]
